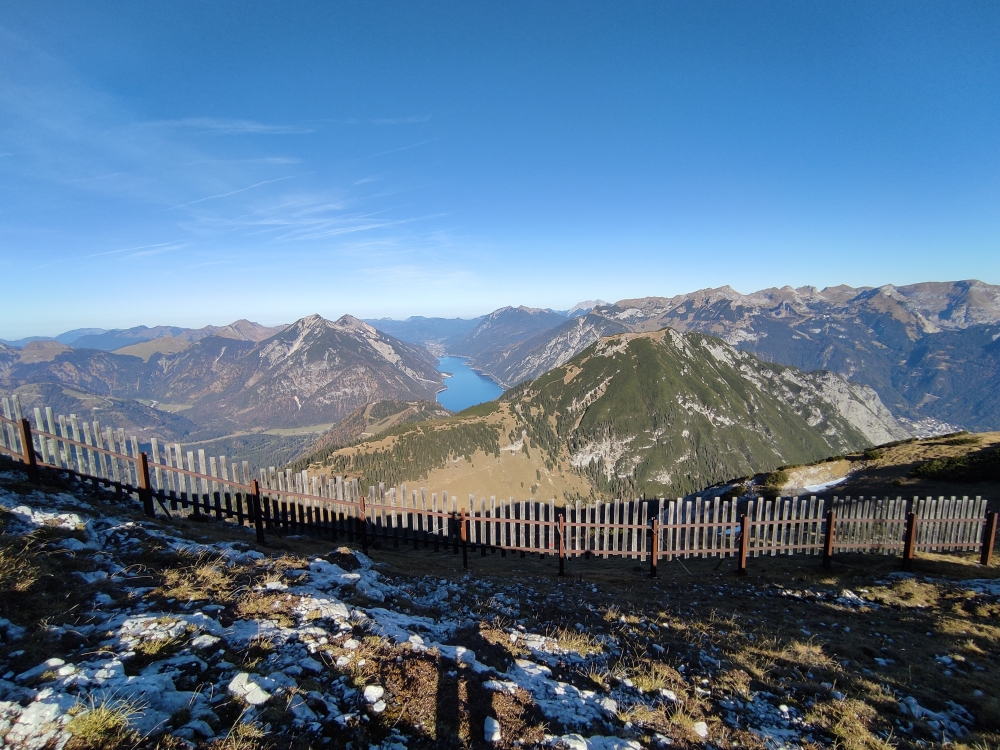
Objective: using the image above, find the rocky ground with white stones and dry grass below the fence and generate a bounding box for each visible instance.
[0,464,1000,750]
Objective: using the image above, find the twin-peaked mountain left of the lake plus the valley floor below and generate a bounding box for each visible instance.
[0,315,442,462]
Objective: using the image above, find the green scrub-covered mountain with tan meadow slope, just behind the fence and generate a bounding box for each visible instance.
[300,329,908,496]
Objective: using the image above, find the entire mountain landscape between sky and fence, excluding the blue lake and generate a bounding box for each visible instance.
[0,281,1000,497]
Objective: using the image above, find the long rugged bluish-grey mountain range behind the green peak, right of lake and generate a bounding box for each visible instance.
[466,281,1000,430]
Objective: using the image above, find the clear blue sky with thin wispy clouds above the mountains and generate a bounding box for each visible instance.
[0,0,1000,338]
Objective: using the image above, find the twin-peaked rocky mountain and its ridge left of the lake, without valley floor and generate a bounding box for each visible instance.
[0,315,441,432]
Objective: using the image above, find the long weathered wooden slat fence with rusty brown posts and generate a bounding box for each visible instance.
[0,395,997,575]
